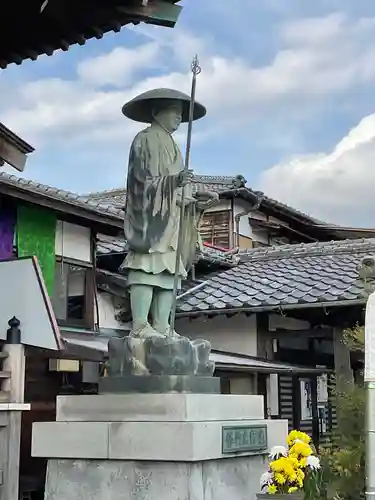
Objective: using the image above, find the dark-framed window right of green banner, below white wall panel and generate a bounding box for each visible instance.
[52,262,94,328]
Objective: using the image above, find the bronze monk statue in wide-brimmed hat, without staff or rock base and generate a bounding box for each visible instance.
[121,89,218,337]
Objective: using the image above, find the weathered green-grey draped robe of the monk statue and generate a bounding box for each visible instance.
[121,123,202,289]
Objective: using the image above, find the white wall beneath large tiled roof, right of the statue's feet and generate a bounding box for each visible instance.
[176,314,257,356]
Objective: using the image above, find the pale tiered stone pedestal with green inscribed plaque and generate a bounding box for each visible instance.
[32,394,287,500]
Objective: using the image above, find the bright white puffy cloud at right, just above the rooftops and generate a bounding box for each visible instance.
[260,113,375,227]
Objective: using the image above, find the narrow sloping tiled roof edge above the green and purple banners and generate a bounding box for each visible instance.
[0,172,123,220]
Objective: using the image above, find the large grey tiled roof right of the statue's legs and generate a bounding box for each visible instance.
[178,238,375,315]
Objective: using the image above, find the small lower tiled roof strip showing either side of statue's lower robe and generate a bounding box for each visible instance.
[97,234,239,267]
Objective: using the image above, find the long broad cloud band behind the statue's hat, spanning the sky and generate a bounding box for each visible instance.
[2,14,375,147]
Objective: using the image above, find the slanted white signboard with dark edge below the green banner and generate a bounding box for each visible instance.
[0,257,63,351]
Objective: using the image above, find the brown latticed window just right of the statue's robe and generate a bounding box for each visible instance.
[200,210,231,248]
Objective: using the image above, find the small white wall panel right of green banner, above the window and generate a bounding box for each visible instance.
[55,221,92,263]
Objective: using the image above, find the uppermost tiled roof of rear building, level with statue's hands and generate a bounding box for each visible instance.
[87,175,322,224]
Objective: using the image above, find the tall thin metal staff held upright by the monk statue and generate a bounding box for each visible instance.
[170,55,202,334]
